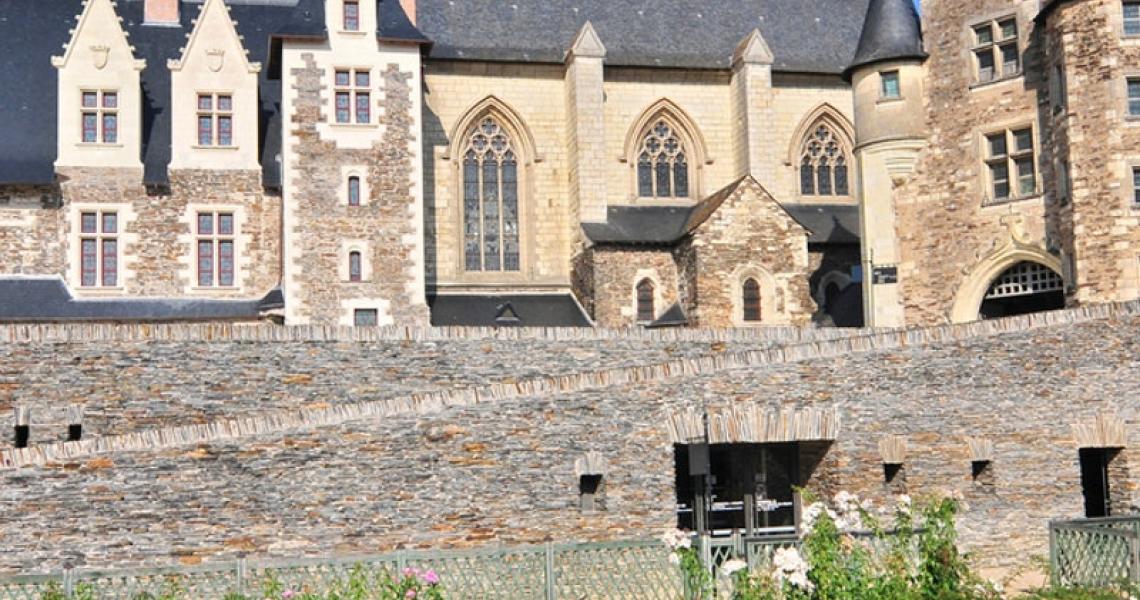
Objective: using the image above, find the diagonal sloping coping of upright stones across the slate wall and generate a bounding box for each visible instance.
[0,301,1140,469]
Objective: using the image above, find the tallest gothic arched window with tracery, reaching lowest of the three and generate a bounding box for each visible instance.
[463,117,520,271]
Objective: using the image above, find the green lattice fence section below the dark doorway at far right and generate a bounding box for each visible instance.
[1049,517,1140,586]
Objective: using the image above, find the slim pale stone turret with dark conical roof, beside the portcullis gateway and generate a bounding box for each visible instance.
[845,0,927,327]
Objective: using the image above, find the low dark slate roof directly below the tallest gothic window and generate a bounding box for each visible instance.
[428,294,593,327]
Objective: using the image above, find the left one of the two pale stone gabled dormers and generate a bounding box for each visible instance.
[51,0,146,169]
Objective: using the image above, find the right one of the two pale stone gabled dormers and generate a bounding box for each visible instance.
[168,0,261,170]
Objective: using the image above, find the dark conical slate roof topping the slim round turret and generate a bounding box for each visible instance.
[845,0,927,75]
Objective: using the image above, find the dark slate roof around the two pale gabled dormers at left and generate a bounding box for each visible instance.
[0,0,426,187]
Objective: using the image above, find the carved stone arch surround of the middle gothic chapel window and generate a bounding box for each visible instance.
[619,98,713,200]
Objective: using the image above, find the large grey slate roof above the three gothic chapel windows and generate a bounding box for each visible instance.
[417,0,869,74]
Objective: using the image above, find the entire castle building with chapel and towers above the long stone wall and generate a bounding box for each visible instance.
[0,0,1140,327]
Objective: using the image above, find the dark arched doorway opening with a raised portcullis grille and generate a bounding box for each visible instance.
[978,260,1065,319]
